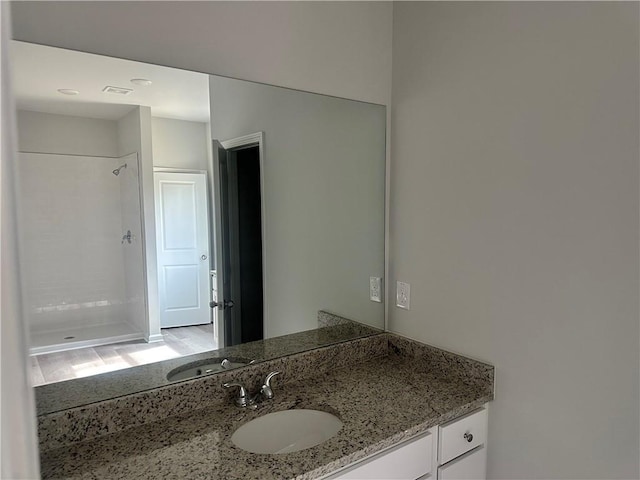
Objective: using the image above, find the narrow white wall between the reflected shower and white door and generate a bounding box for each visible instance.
[118,107,162,341]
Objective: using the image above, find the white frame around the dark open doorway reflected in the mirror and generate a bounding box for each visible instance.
[215,131,269,346]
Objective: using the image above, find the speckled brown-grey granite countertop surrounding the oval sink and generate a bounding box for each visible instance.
[41,334,494,480]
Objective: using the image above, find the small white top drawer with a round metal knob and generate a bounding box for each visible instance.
[438,408,487,465]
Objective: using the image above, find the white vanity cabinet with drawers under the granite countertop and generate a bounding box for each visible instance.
[324,405,488,480]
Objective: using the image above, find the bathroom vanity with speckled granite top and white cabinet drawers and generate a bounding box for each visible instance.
[39,333,494,480]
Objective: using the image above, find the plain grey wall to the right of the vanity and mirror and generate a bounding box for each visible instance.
[390,2,640,479]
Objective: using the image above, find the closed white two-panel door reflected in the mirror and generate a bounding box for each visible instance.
[154,172,211,328]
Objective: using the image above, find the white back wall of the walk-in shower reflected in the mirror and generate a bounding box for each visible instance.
[17,111,125,332]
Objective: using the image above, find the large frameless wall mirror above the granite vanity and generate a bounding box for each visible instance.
[13,41,386,413]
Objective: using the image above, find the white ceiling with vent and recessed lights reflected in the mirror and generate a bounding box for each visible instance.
[11,41,209,122]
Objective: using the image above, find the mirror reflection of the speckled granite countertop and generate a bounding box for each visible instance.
[35,322,381,415]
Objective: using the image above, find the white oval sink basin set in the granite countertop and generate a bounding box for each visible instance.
[231,409,342,453]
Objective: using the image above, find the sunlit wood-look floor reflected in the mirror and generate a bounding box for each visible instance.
[31,324,218,386]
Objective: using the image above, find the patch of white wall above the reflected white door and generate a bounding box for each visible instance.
[151,117,210,170]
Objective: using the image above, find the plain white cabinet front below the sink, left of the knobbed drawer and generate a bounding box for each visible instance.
[330,434,433,480]
